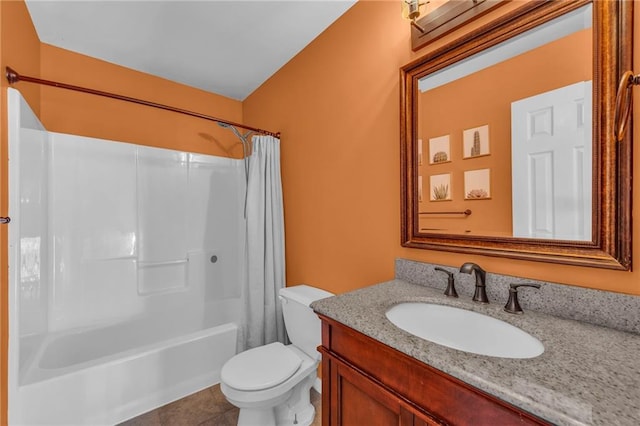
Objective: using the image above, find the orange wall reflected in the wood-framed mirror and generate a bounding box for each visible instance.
[418,29,593,237]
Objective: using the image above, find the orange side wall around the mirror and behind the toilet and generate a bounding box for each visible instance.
[244,1,640,295]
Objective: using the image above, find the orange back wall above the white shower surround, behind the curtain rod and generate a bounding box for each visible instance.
[38,44,242,158]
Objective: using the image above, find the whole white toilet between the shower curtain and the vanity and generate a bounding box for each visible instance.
[220,285,333,426]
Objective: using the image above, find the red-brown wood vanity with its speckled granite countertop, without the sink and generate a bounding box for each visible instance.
[313,280,640,426]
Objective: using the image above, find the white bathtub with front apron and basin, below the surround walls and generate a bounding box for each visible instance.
[9,323,238,426]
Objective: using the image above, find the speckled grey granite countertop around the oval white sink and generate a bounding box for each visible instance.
[311,280,640,425]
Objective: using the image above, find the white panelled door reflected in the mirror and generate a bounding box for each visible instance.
[511,81,593,241]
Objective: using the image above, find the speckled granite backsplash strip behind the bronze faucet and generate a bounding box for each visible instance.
[395,259,640,334]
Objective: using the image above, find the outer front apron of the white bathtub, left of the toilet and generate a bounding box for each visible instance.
[9,320,237,426]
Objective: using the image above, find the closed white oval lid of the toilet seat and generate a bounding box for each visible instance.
[220,342,302,391]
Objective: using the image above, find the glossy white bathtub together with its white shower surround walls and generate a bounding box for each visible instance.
[9,89,245,425]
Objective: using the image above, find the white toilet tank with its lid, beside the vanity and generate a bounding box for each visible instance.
[280,284,333,359]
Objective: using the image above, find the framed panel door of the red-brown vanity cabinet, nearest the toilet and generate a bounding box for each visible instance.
[329,360,439,426]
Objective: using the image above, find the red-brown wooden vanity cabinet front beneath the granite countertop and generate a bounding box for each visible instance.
[318,315,549,426]
